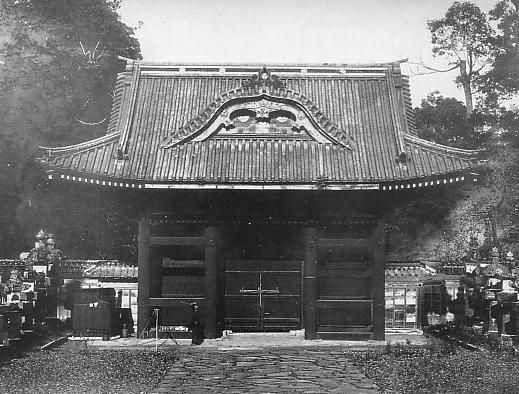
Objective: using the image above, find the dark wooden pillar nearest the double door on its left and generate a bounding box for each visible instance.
[204,227,219,338]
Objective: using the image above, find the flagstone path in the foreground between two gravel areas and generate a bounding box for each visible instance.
[154,347,379,394]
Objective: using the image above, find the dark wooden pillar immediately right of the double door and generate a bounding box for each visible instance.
[303,227,319,339]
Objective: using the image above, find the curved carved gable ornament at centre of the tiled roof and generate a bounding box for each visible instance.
[162,68,350,148]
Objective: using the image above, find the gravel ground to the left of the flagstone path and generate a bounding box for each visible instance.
[0,348,174,394]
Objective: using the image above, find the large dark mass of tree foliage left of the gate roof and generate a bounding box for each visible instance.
[0,0,140,256]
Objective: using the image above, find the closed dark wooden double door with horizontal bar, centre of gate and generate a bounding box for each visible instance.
[225,260,302,331]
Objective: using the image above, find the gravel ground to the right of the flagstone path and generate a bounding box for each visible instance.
[352,348,519,394]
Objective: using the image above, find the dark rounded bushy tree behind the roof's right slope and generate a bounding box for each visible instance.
[413,91,486,148]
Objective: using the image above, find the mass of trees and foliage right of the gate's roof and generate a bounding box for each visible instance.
[409,0,519,260]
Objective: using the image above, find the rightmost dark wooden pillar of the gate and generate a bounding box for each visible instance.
[371,221,386,341]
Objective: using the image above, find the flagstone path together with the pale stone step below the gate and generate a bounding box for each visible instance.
[76,331,443,394]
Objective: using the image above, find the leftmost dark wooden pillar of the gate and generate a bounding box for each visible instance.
[137,218,150,335]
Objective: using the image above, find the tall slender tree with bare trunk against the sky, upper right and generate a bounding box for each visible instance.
[428,2,495,118]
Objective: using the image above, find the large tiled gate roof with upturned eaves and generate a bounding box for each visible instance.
[39,62,478,188]
